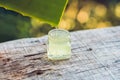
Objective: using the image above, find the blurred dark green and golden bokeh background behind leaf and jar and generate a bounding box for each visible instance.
[0,0,120,42]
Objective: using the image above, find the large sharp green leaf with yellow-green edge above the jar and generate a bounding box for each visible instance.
[0,0,68,26]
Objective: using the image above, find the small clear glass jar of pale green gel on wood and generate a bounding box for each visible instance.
[47,29,71,60]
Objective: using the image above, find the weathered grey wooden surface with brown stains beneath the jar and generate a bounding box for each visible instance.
[0,27,120,80]
